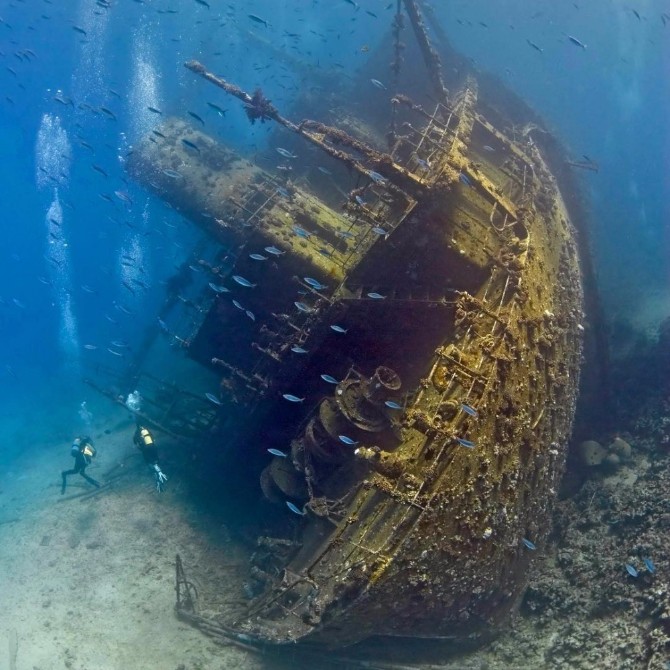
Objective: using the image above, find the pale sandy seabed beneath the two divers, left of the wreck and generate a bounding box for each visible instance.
[0,400,268,670]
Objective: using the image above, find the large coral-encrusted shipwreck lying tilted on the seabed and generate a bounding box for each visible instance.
[93,0,584,660]
